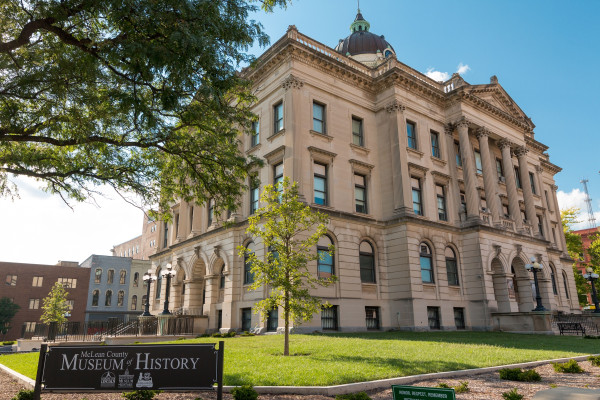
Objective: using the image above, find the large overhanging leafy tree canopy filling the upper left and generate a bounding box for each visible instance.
[0,0,287,216]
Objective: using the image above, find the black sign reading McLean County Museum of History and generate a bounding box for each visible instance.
[36,342,223,392]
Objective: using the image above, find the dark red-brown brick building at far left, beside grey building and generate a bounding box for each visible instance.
[0,261,90,340]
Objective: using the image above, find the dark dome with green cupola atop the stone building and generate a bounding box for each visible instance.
[335,10,396,62]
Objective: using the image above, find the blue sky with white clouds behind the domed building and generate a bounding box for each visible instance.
[0,0,600,264]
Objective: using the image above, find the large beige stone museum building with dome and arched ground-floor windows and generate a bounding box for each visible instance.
[144,12,579,332]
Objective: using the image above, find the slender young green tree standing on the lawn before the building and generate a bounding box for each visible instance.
[238,177,336,356]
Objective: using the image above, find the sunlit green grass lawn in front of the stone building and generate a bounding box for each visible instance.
[0,332,600,386]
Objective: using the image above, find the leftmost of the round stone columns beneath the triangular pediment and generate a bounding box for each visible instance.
[456,117,480,220]
